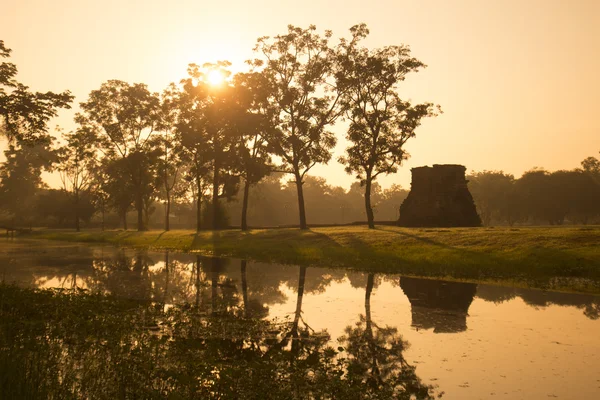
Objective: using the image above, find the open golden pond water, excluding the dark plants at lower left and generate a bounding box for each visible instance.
[0,241,600,399]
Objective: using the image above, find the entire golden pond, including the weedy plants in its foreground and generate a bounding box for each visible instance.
[0,241,600,399]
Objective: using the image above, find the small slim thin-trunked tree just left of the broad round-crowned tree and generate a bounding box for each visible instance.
[58,129,97,228]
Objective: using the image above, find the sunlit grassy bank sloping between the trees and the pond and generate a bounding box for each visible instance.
[22,226,600,293]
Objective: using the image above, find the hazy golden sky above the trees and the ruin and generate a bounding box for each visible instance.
[0,0,600,188]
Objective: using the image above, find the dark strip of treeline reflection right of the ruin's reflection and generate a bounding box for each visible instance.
[477,285,600,319]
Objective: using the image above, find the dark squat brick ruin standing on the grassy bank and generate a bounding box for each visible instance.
[398,164,481,227]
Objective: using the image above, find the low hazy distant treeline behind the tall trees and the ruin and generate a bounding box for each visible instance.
[5,157,600,229]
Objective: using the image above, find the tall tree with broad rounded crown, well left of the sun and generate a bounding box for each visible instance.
[76,80,160,231]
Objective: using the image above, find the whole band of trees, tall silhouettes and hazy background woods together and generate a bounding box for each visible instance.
[0,28,600,230]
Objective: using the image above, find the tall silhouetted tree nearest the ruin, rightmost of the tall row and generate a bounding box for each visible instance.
[337,24,439,229]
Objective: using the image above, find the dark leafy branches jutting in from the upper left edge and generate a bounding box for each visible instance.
[0,40,73,143]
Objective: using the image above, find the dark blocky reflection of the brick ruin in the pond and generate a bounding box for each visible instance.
[400,276,477,333]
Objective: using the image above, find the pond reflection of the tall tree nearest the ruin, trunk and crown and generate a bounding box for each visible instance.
[338,273,433,399]
